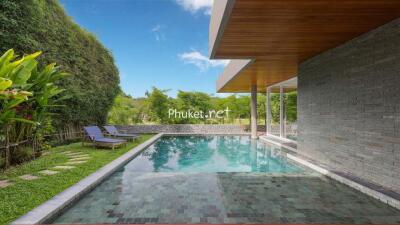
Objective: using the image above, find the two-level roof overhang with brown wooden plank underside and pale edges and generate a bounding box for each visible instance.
[209,0,400,93]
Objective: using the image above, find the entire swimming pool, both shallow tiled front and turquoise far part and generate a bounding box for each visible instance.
[53,136,400,224]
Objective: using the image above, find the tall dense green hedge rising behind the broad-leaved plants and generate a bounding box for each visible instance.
[0,0,120,127]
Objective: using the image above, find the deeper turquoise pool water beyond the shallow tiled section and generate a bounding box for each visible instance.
[125,136,302,173]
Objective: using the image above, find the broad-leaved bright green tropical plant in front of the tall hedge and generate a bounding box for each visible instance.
[0,49,68,167]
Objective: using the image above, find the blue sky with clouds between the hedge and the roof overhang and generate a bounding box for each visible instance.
[61,0,227,97]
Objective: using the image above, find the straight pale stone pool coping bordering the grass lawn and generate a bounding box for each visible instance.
[10,133,165,225]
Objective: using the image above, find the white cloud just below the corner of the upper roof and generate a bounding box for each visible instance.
[178,50,229,71]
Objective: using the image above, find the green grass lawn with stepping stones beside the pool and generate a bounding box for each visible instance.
[0,135,152,224]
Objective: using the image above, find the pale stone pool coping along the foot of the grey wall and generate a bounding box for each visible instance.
[260,138,400,210]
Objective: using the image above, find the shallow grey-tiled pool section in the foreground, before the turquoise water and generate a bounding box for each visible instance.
[54,171,400,224]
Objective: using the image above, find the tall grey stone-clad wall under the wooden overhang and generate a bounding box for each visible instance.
[298,19,400,192]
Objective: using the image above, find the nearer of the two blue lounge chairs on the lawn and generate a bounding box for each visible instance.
[82,126,126,150]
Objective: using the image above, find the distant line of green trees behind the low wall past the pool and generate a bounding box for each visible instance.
[108,87,297,125]
